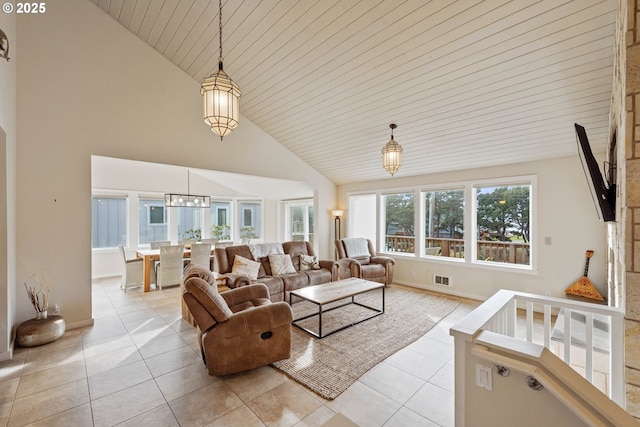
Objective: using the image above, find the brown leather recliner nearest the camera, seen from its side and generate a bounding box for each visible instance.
[182,266,292,376]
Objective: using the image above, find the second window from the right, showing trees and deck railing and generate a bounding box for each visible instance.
[422,188,465,258]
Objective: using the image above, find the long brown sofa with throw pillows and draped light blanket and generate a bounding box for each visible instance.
[215,241,338,301]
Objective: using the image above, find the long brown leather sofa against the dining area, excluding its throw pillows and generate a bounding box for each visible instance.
[215,241,338,301]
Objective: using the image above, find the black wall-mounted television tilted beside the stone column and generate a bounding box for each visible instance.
[575,123,616,222]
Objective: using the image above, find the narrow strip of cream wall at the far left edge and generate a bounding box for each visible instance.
[0,9,18,361]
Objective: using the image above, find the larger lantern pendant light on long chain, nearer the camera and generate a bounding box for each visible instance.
[200,0,242,141]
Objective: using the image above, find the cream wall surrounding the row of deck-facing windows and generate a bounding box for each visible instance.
[338,153,607,300]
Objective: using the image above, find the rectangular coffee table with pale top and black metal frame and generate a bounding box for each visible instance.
[289,278,385,338]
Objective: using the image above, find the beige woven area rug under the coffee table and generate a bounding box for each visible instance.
[272,285,459,399]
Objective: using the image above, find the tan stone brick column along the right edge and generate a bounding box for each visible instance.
[618,0,640,418]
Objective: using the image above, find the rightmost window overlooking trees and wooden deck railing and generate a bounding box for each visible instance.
[475,183,531,266]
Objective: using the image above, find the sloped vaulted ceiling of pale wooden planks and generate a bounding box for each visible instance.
[90,0,617,184]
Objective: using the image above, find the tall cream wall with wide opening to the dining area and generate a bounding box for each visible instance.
[16,0,336,326]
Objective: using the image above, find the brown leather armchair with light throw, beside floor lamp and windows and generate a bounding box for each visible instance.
[334,237,395,285]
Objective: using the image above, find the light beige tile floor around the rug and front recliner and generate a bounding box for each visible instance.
[0,278,479,427]
